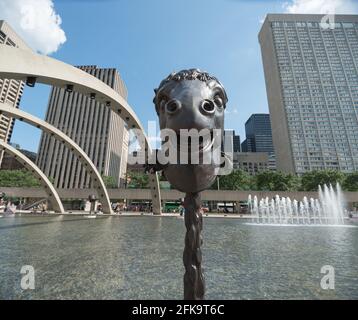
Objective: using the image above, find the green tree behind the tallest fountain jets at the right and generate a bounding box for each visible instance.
[301,170,345,191]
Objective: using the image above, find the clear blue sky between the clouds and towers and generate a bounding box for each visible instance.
[4,0,354,151]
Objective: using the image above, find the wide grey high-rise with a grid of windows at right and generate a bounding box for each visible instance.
[259,14,358,174]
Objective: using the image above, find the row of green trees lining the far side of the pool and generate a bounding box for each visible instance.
[0,169,358,191]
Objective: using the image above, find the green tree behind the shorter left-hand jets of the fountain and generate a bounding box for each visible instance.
[255,171,300,191]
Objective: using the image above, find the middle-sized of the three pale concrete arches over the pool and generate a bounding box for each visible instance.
[0,102,112,213]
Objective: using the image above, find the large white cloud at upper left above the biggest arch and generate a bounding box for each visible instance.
[0,0,66,54]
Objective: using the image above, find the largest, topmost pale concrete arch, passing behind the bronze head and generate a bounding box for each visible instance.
[0,45,161,214]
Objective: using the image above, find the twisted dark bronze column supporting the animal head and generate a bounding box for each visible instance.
[183,193,205,300]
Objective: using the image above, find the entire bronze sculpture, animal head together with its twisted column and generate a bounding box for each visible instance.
[147,69,228,300]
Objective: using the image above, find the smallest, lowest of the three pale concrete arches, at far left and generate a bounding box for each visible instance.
[0,140,65,213]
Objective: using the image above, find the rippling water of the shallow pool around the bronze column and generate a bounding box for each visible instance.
[0,216,358,299]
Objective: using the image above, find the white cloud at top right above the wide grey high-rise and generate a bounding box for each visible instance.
[283,0,358,14]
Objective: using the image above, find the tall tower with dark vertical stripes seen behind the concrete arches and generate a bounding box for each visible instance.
[37,66,129,189]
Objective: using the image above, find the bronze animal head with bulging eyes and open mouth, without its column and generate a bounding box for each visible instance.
[153,69,228,192]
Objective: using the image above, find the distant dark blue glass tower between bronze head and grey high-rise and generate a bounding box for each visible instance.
[242,113,274,154]
